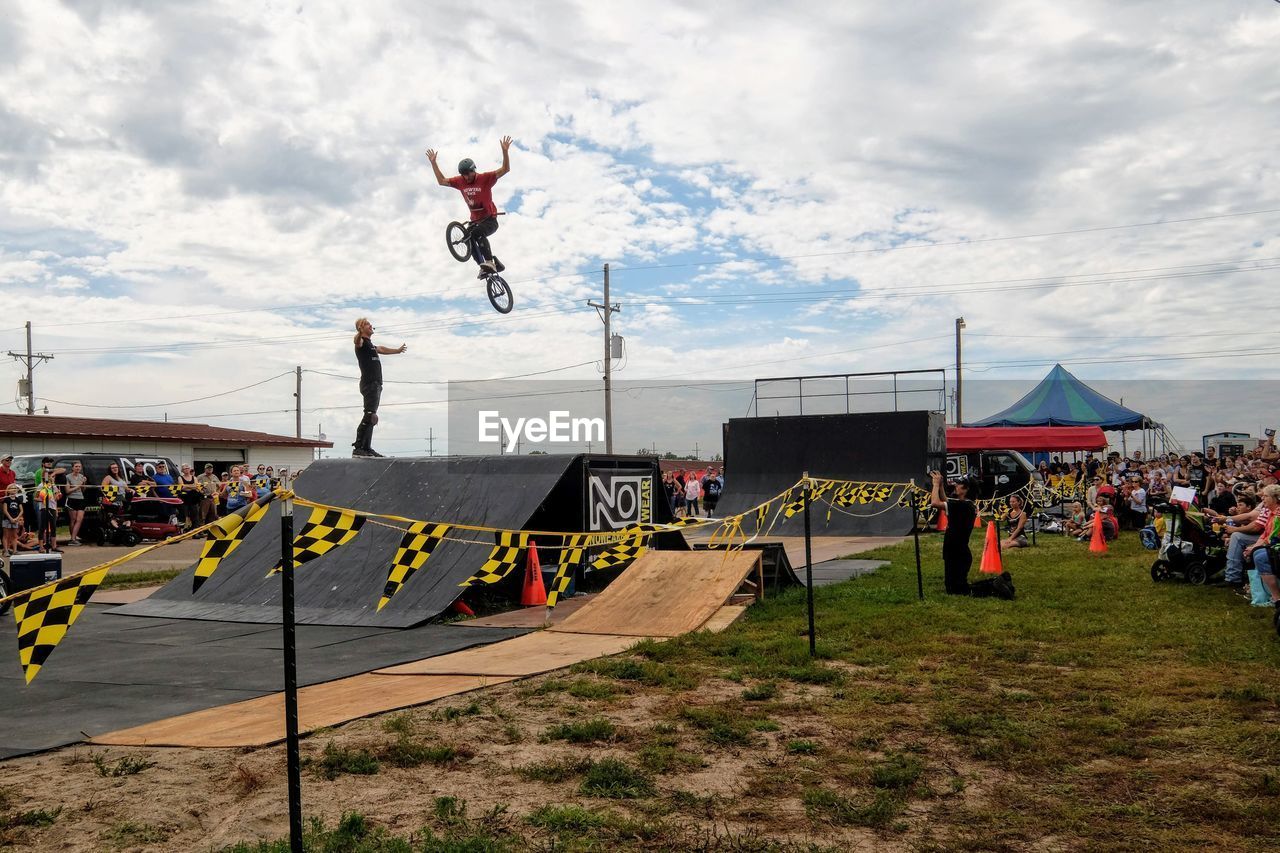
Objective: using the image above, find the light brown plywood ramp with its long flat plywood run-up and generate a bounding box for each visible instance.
[91,551,760,747]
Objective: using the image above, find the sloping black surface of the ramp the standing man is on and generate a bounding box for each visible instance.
[115,456,581,628]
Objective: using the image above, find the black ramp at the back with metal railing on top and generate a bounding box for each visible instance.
[716,411,946,535]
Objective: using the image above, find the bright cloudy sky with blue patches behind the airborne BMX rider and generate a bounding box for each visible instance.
[0,0,1280,453]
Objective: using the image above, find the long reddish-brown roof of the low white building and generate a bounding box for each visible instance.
[0,415,333,447]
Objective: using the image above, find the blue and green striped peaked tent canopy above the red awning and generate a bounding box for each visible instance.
[965,364,1155,430]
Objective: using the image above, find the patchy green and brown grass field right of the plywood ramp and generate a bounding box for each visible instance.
[2,527,1280,852]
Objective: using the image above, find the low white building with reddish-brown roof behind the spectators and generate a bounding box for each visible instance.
[0,415,333,471]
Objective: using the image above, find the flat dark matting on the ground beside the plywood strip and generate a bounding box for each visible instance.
[0,605,526,758]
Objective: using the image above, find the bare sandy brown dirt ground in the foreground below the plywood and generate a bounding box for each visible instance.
[0,671,991,853]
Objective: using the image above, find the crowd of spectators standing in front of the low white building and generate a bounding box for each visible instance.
[0,455,298,557]
